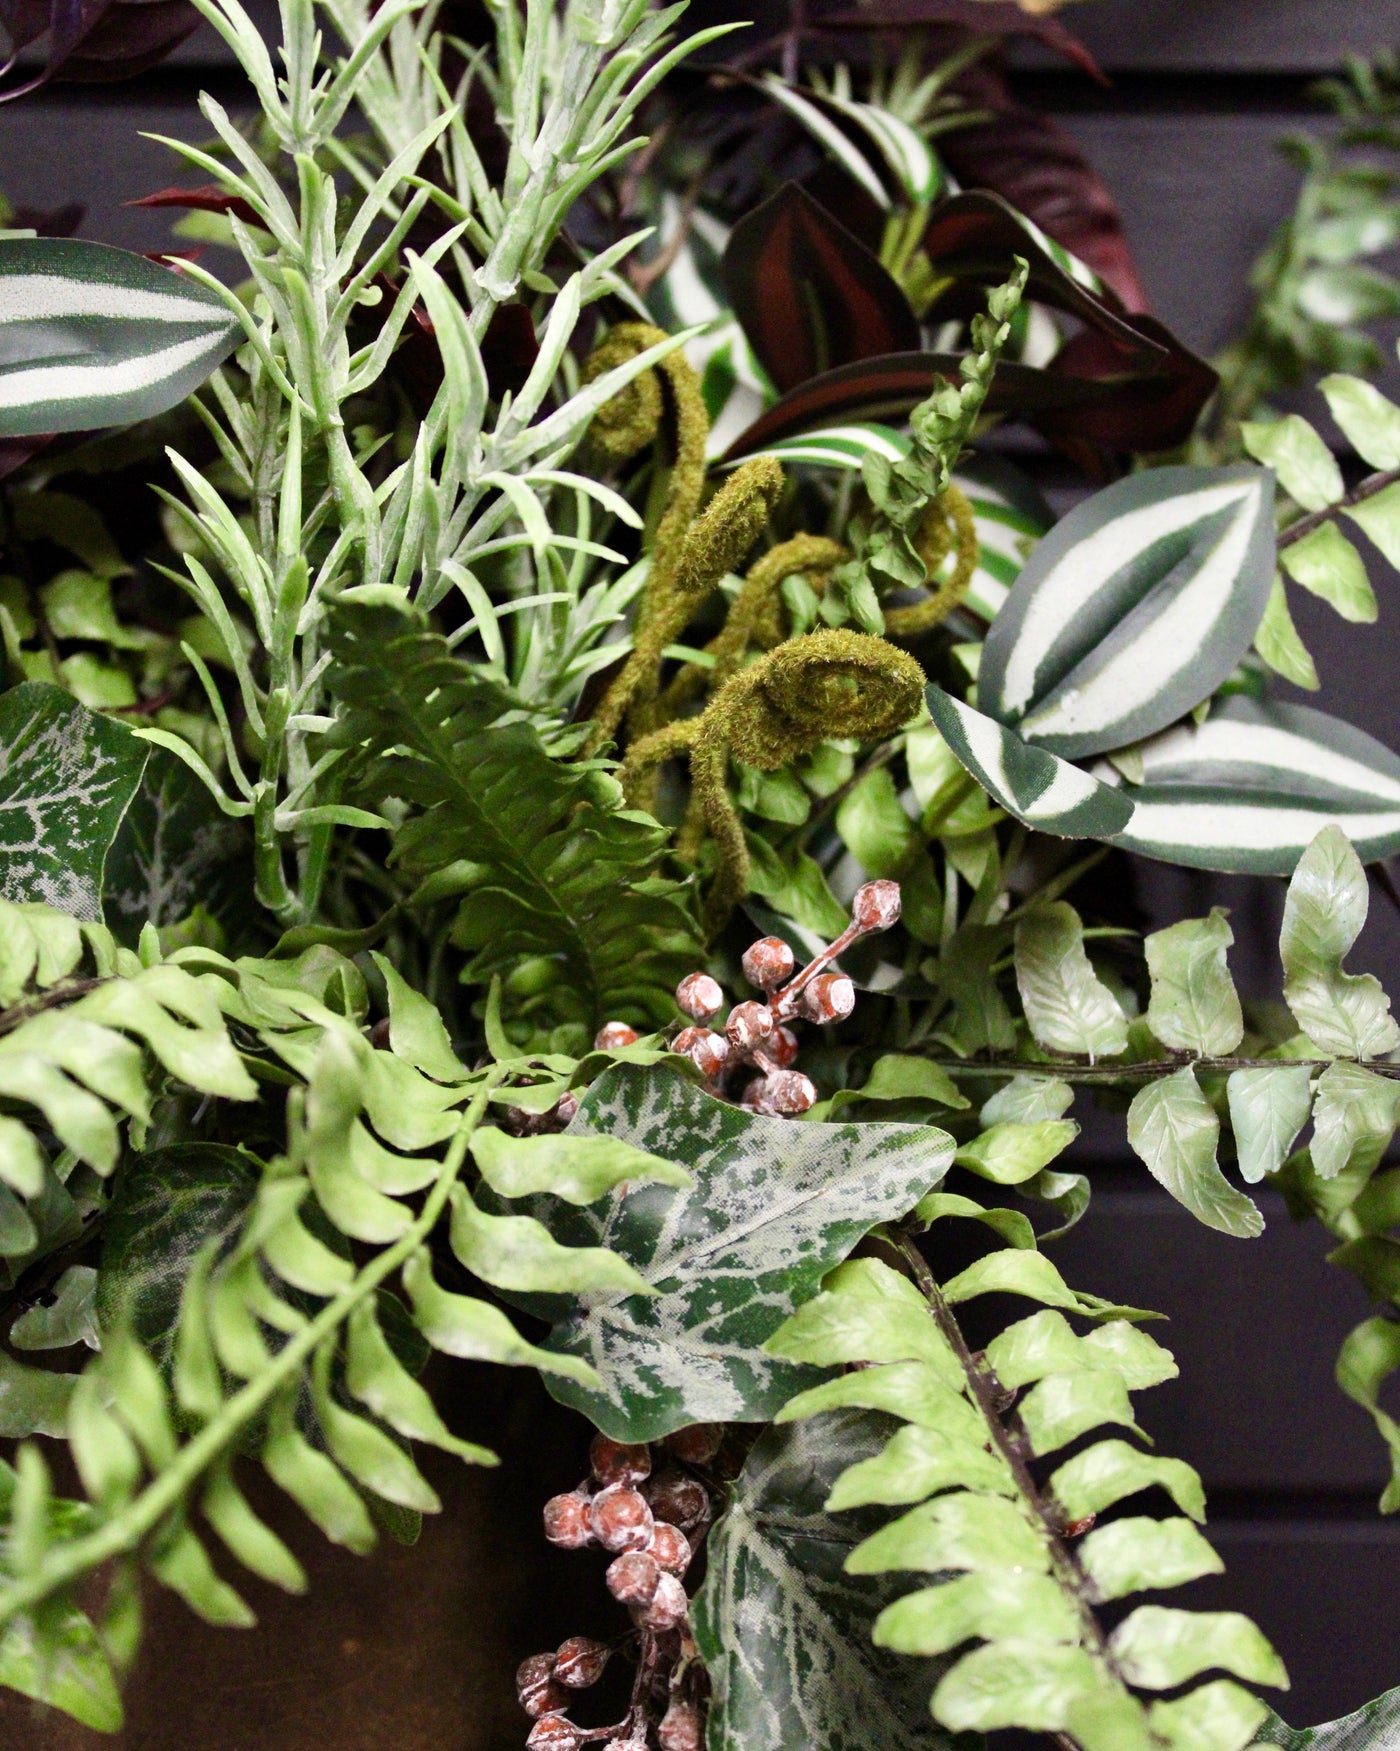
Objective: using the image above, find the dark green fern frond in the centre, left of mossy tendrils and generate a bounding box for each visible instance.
[331,606,700,1049]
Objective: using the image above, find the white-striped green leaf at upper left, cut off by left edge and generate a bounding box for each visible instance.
[0,236,242,438]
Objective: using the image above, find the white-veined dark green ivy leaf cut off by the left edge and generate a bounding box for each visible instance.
[0,682,147,921]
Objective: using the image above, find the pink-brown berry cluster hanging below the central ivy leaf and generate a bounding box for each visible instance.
[516,1424,725,1751]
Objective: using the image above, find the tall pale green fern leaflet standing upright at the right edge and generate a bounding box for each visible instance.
[1279,826,1400,1058]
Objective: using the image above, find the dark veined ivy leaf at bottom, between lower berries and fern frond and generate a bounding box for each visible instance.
[691,1411,956,1751]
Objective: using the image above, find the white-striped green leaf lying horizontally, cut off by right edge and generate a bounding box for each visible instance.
[1094,695,1400,876]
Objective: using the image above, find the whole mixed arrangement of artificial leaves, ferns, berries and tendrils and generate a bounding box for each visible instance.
[0,0,1400,1751]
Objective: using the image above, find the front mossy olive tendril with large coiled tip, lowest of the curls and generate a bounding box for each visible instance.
[621,629,924,935]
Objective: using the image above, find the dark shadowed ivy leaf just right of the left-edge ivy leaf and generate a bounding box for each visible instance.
[102,744,256,947]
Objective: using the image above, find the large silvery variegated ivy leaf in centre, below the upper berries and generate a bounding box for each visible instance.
[483,1065,952,1441]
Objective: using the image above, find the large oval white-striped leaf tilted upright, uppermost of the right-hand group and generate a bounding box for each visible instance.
[978,466,1274,758]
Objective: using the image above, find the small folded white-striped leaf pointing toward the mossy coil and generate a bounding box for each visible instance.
[926,685,1132,839]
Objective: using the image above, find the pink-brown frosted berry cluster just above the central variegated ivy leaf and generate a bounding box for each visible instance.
[658,881,900,1119]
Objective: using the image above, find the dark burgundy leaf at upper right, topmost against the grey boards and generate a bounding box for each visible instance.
[940,61,1148,310]
